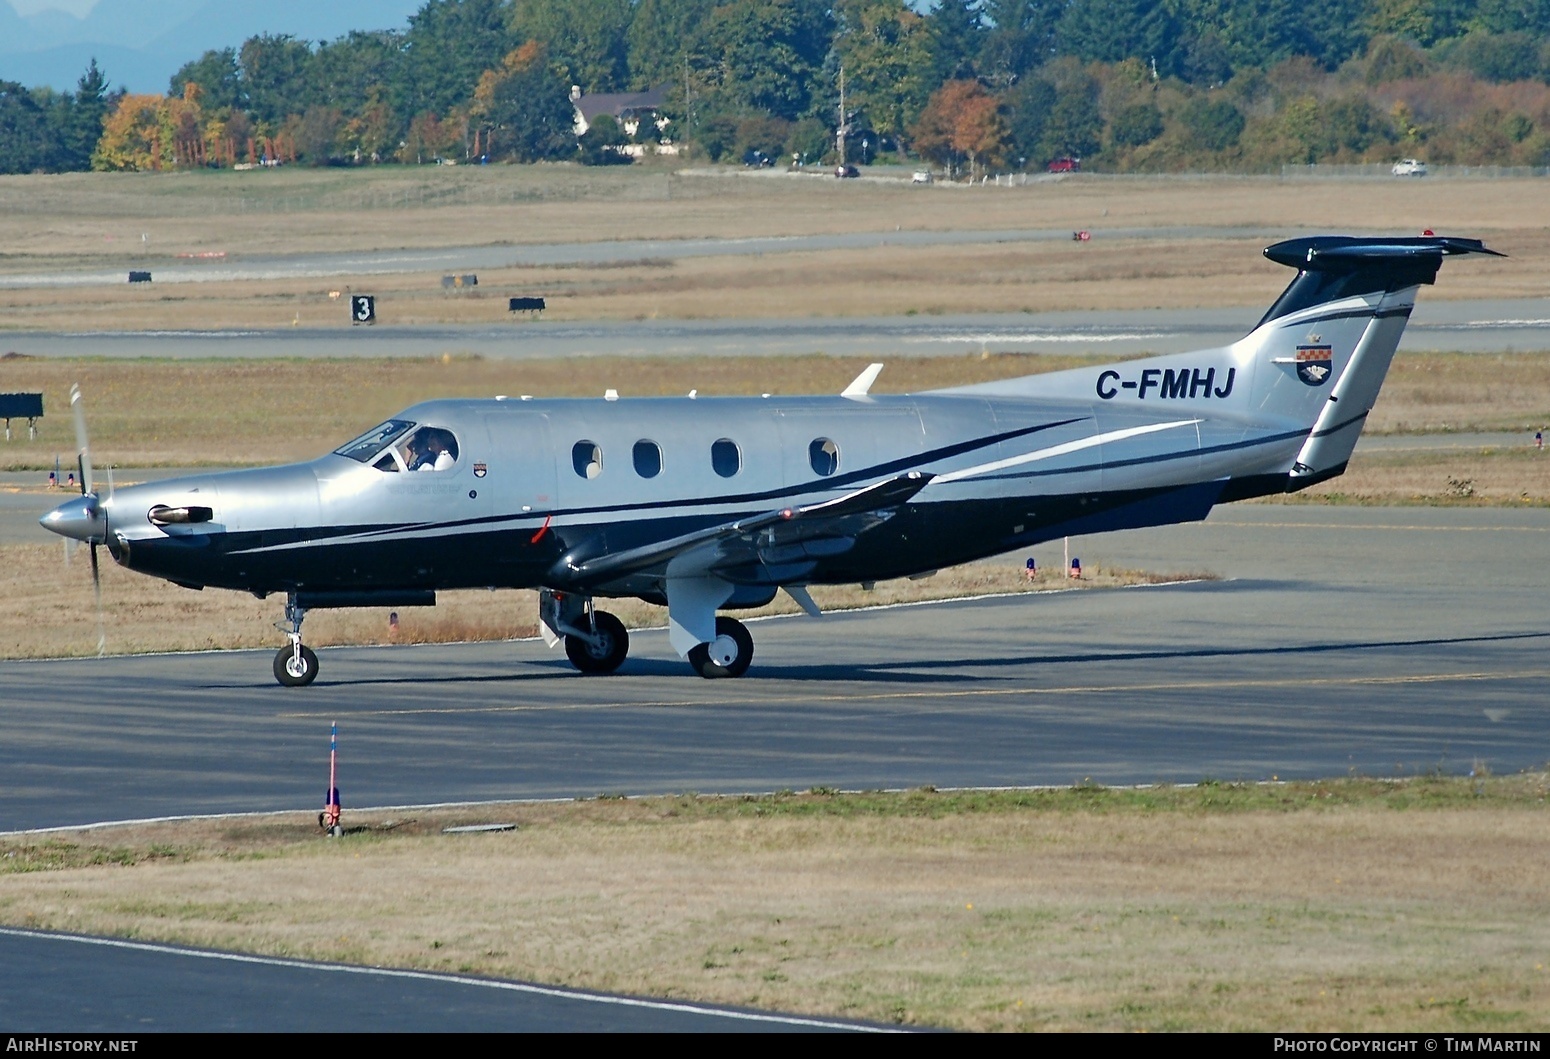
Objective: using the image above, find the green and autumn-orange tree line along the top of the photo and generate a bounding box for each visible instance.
[0,0,1550,174]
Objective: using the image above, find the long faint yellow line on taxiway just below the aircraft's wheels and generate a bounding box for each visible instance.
[276,670,1550,718]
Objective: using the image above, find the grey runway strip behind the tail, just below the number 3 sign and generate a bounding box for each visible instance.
[0,296,1550,360]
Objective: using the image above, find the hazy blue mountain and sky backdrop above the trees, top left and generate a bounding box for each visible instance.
[0,0,425,93]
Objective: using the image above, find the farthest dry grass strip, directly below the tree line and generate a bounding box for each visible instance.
[0,166,1550,260]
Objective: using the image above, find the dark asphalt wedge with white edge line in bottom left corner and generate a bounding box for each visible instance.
[0,927,876,1029]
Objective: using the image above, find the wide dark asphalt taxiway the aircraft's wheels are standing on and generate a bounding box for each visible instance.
[0,505,1550,830]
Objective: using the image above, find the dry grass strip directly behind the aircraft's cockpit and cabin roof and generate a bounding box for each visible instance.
[0,354,1550,468]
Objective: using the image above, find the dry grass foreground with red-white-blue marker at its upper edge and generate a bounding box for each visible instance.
[0,777,1550,1031]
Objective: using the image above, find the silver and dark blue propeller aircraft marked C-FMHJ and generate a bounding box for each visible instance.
[42,234,1500,685]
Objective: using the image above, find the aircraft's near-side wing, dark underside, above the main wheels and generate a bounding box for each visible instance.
[555,471,933,586]
